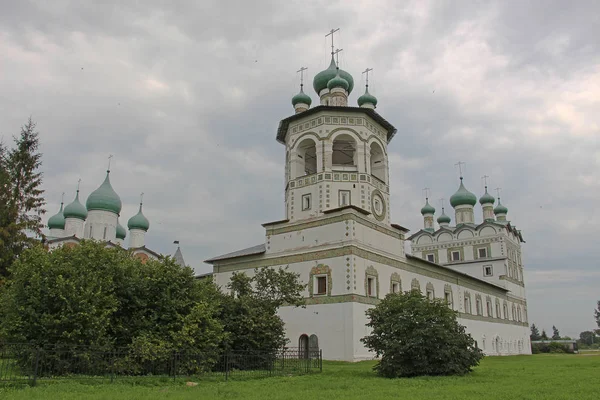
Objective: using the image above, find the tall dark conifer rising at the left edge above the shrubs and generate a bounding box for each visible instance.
[0,118,46,278]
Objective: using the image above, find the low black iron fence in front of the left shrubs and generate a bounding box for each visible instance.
[0,344,323,385]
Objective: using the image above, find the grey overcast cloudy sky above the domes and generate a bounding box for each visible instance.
[0,0,600,335]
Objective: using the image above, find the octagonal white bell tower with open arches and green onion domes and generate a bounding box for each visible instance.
[277,32,396,225]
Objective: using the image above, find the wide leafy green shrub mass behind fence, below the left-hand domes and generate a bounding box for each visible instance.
[0,241,226,372]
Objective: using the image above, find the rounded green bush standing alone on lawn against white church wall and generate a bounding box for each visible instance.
[361,291,483,378]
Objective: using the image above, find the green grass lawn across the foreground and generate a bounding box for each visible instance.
[0,355,600,400]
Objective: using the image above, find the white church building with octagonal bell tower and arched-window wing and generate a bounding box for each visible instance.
[206,43,530,361]
